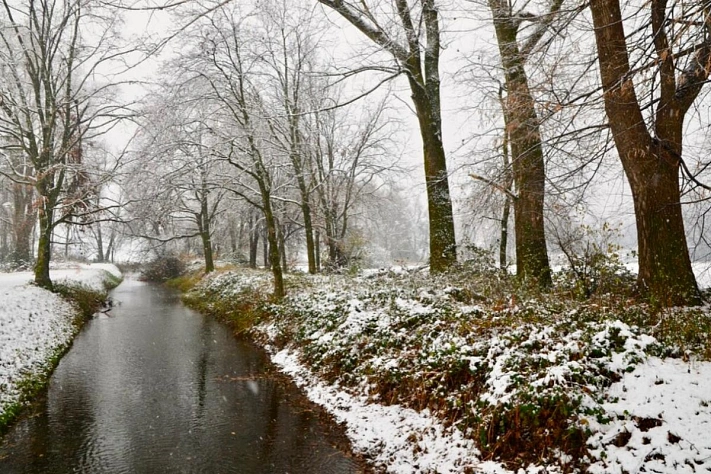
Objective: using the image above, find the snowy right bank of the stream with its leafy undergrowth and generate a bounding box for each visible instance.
[182,270,711,474]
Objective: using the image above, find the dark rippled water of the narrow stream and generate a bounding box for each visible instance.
[0,280,360,474]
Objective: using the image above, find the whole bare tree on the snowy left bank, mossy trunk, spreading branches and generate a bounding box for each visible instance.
[0,0,131,288]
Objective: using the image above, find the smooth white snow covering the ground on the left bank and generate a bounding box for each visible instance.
[0,264,121,417]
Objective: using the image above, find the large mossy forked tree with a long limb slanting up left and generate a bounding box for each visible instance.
[319,0,457,272]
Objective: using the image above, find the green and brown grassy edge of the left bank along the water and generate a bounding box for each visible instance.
[0,270,123,436]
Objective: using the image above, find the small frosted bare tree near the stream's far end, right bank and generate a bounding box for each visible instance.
[126,90,225,273]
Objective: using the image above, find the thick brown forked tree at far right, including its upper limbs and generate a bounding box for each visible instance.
[590,0,711,305]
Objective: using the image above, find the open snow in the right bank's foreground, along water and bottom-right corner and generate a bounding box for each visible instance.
[272,318,711,474]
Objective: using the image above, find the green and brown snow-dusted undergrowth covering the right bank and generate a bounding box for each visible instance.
[184,265,711,472]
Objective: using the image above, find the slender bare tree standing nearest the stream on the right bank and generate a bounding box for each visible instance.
[177,7,285,298]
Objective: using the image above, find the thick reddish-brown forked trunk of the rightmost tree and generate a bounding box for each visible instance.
[590,0,708,306]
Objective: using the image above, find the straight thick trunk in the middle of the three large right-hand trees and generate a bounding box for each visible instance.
[489,6,552,287]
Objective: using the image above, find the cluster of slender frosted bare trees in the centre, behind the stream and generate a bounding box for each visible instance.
[121,1,398,297]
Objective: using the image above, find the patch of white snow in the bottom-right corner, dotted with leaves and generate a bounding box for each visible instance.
[588,358,711,474]
